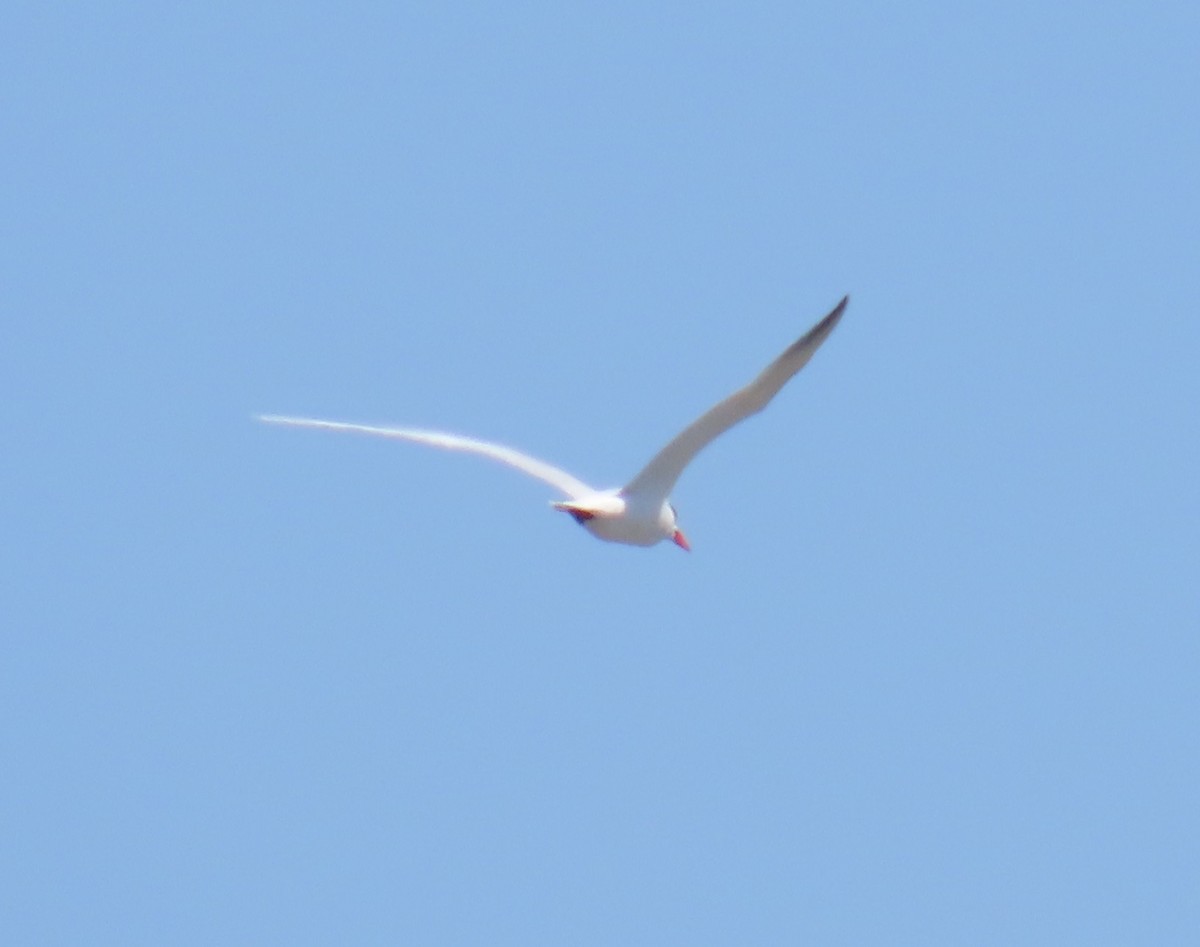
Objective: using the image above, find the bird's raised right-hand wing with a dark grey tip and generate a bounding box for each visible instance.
[622,296,850,503]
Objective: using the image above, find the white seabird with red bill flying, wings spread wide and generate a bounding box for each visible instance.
[257,295,850,551]
